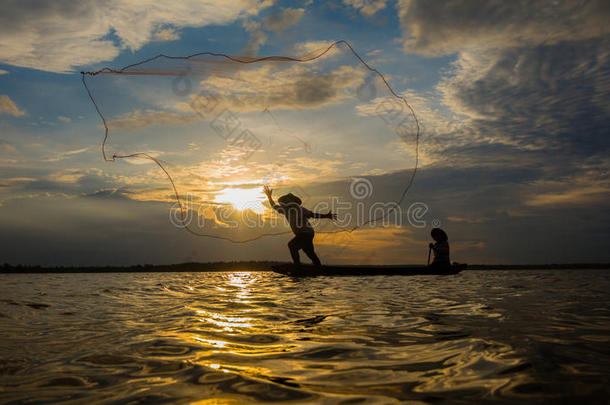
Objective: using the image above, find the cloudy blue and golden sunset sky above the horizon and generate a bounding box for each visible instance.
[0,0,610,266]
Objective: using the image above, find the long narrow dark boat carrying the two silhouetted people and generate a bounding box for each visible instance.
[271,263,468,277]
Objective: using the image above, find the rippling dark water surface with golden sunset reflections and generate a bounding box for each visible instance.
[0,270,610,404]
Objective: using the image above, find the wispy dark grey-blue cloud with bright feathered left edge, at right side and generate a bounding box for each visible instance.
[438,39,610,156]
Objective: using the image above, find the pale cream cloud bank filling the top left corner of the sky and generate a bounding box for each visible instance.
[0,0,272,73]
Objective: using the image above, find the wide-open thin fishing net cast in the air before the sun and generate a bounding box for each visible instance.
[82,41,419,242]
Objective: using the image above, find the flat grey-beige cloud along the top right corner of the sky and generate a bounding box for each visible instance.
[398,0,610,56]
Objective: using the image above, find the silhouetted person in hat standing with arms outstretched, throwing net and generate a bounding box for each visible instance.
[263,186,337,267]
